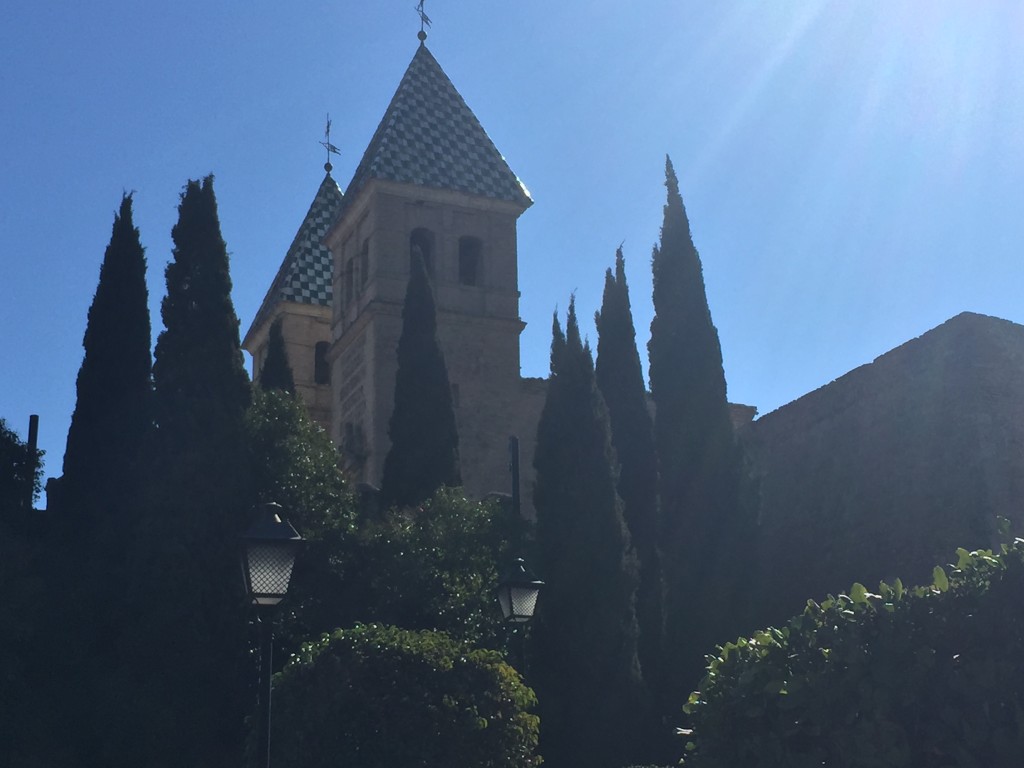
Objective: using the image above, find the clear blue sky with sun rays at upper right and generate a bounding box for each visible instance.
[0,0,1024,489]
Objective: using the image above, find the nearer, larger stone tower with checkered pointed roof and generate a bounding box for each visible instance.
[325,43,531,496]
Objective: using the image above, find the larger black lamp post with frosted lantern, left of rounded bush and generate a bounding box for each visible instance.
[242,504,302,768]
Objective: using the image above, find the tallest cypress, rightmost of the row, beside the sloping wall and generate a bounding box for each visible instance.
[648,159,750,717]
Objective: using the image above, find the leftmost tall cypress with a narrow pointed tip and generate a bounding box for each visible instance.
[54,195,153,765]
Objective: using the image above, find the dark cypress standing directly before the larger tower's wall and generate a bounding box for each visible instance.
[381,249,462,509]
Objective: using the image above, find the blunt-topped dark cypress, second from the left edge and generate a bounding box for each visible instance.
[124,177,254,766]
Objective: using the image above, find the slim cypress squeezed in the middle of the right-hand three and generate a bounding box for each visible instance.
[595,247,664,716]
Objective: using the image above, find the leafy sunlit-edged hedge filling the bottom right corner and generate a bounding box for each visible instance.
[685,540,1024,768]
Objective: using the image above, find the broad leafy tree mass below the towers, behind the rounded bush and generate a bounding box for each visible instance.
[247,390,524,658]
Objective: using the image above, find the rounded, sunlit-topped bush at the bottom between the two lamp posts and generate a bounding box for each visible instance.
[271,626,540,768]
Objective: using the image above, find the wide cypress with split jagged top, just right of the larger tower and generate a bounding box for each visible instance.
[530,303,642,768]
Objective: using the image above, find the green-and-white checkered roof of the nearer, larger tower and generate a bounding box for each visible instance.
[346,45,532,207]
